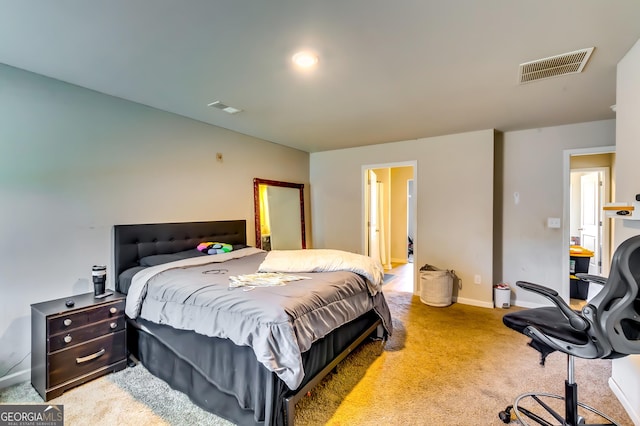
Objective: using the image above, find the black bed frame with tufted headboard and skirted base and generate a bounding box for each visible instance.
[113,220,384,425]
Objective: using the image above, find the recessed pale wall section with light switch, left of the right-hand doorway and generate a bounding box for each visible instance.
[502,120,615,306]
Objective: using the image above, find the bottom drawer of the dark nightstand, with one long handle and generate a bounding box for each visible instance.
[47,330,126,388]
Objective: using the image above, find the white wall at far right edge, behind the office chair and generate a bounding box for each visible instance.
[610,40,640,425]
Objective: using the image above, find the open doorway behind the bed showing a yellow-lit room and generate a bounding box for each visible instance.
[362,162,417,288]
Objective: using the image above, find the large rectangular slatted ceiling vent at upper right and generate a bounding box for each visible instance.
[518,47,594,84]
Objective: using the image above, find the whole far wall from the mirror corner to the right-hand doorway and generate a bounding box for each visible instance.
[310,120,615,307]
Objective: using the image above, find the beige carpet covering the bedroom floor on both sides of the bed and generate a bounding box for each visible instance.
[0,285,632,426]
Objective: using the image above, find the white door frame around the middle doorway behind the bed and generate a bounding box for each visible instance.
[360,160,420,294]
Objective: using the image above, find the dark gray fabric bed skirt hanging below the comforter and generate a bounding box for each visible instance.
[128,311,381,426]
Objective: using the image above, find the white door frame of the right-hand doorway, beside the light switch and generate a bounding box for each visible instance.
[559,145,616,302]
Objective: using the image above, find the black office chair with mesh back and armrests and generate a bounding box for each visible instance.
[498,235,640,426]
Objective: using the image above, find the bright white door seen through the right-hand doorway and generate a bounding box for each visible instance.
[579,172,602,275]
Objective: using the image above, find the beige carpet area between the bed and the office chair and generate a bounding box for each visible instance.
[297,292,633,426]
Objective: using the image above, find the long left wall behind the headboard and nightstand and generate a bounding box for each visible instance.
[0,65,309,387]
